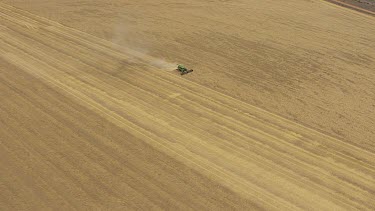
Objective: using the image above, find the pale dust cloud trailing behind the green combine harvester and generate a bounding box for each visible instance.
[111,15,177,71]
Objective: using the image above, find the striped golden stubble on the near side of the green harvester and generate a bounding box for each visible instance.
[0,4,375,210]
